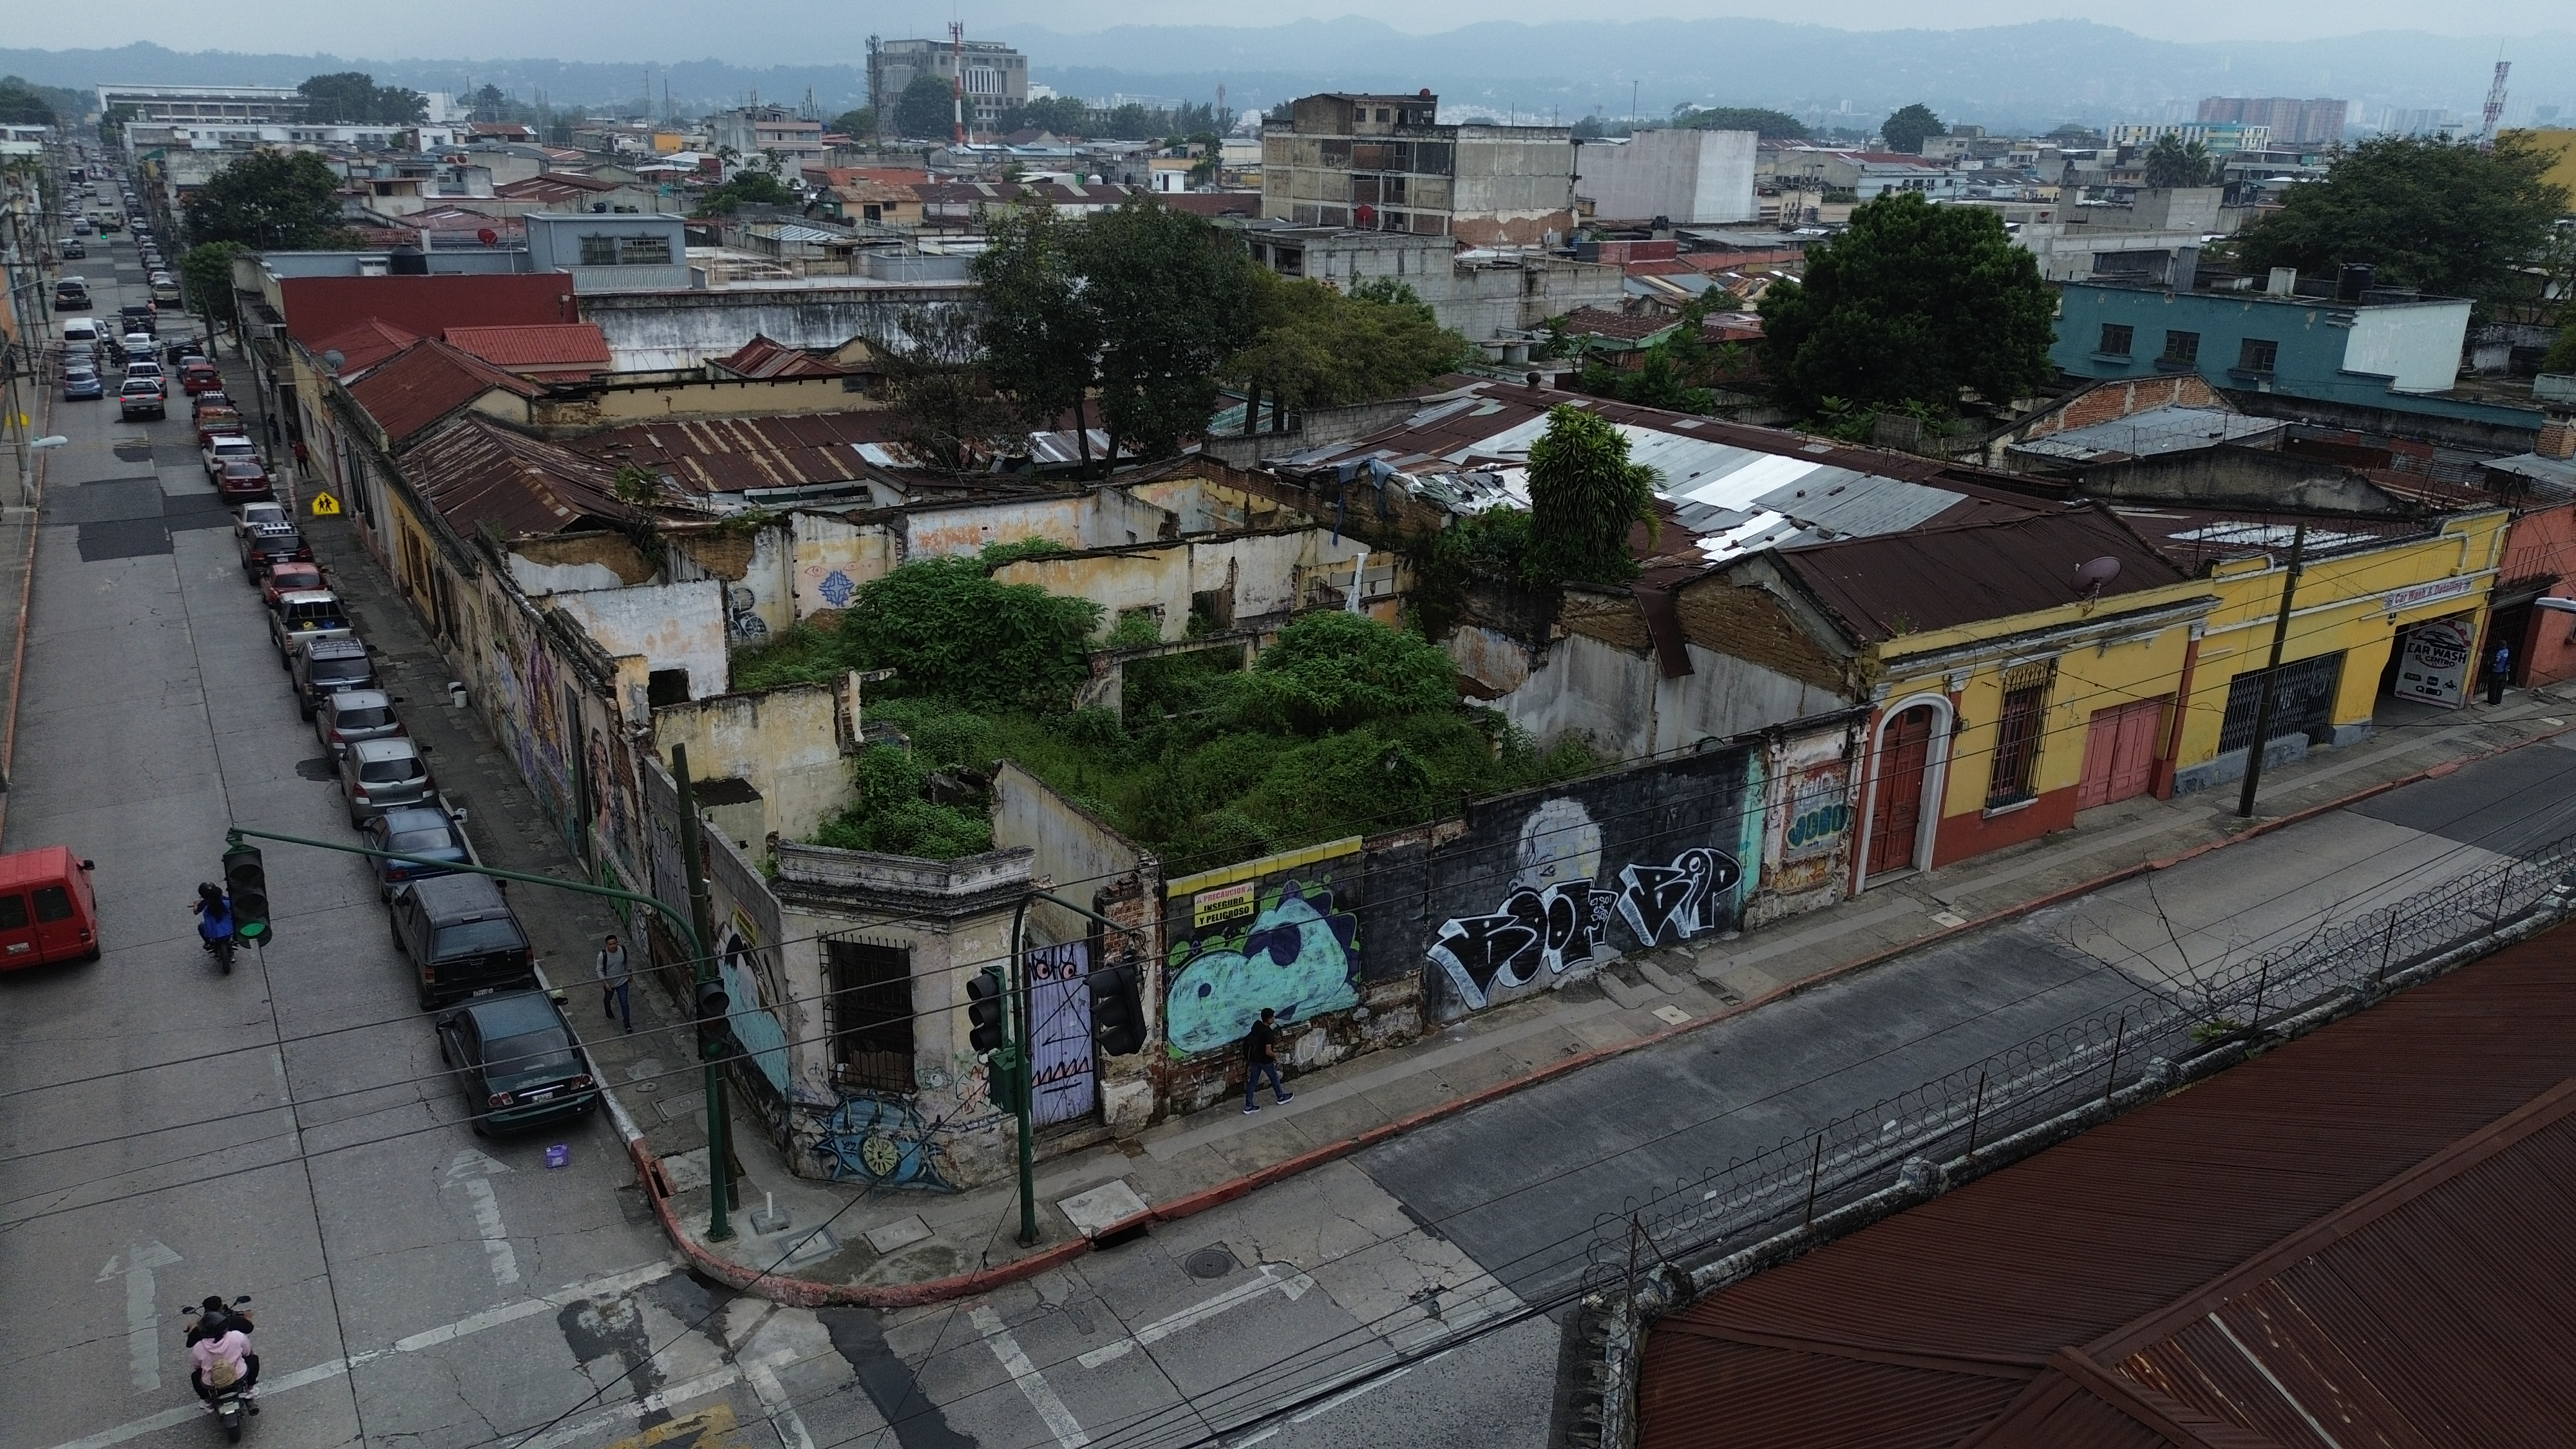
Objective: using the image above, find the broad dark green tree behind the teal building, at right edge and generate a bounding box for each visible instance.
[2236,131,2568,312]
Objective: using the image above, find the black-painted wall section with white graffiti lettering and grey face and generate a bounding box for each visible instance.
[1360,745,1759,1021]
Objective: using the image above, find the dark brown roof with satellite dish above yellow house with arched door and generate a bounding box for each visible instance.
[1777,506,2187,642]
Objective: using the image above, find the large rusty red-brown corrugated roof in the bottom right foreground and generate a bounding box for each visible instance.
[1638,928,2576,1449]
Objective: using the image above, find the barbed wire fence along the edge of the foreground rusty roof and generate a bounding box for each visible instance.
[1564,835,2576,1449]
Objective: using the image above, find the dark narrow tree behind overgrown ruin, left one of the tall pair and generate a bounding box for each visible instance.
[974,206,1100,472]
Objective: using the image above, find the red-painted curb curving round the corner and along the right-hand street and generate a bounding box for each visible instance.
[626,724,2576,1307]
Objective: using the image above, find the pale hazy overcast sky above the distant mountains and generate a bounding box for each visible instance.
[20,0,2576,64]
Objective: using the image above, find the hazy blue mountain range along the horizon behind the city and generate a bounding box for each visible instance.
[0,18,2576,126]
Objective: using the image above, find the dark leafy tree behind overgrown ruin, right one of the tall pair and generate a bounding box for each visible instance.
[1074,196,1252,459]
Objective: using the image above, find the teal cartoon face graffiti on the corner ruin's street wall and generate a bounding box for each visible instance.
[1164,882,1360,1057]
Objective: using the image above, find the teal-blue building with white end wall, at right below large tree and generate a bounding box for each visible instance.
[2048,270,2540,428]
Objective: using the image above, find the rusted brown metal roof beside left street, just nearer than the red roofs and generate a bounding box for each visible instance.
[402,413,641,539]
